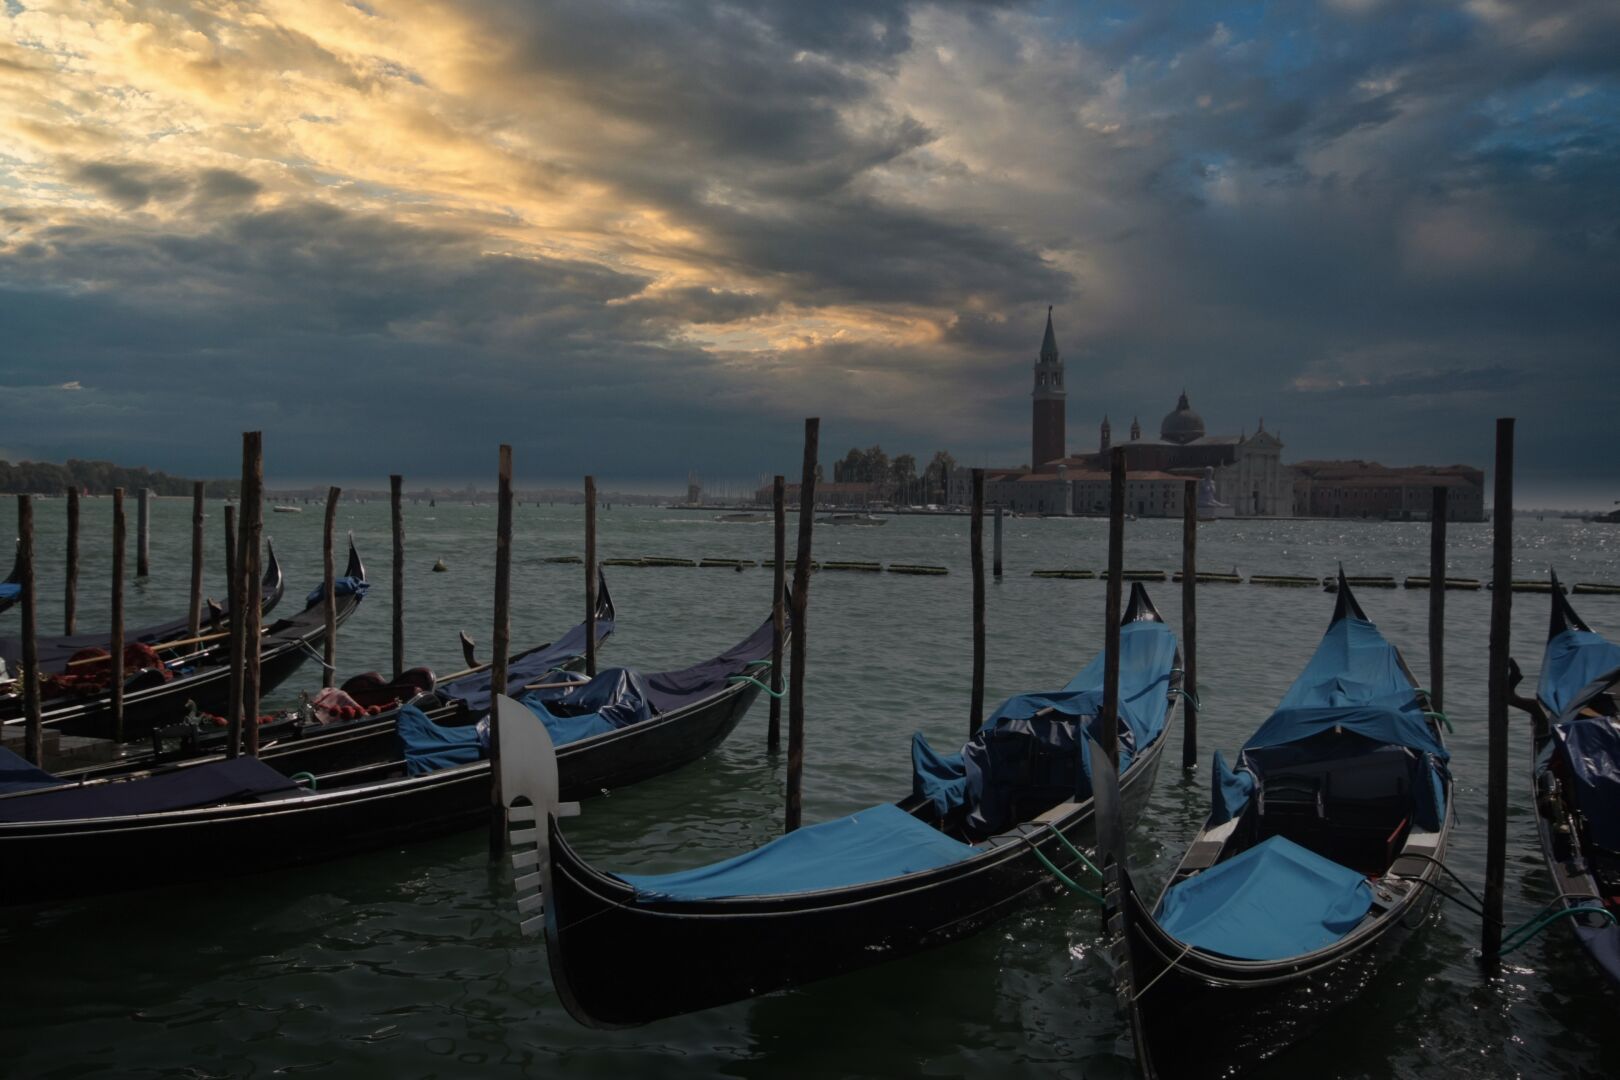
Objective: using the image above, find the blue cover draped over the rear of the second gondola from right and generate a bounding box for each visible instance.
[1212,614,1450,827]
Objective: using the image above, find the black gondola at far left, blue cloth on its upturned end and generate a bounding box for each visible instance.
[0,538,356,740]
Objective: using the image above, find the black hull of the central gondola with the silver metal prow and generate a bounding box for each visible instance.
[544,722,1165,1027]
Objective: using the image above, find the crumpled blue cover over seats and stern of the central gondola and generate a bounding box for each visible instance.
[912,620,1176,834]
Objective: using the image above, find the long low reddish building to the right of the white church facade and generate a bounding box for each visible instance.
[1293,460,1486,521]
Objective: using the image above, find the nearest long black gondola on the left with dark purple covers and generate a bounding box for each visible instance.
[0,605,771,905]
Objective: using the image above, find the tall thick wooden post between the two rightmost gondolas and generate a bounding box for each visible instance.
[1481,416,1513,965]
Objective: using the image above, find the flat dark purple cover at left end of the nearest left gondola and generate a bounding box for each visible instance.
[0,758,301,821]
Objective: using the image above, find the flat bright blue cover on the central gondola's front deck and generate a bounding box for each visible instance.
[619,803,978,900]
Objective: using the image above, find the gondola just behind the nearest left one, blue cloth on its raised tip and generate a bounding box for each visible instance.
[58,573,617,784]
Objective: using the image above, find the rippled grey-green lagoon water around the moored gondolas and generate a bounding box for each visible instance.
[0,499,1620,1078]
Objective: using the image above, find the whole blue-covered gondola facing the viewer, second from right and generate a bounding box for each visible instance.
[1105,573,1453,1077]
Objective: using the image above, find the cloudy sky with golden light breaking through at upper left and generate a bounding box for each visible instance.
[0,0,1620,505]
